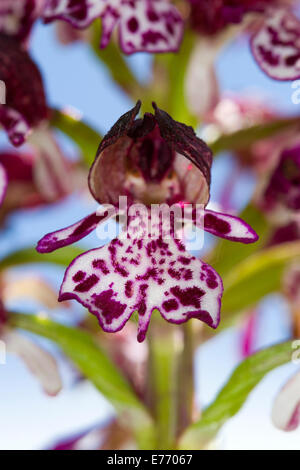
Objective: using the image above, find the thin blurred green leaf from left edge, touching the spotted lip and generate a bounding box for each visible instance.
[0,246,84,270]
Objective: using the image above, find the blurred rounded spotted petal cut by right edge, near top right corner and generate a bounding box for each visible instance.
[251,9,300,80]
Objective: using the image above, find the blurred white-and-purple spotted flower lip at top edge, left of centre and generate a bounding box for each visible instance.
[43,0,183,54]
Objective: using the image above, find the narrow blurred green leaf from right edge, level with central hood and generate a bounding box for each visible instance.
[209,117,300,154]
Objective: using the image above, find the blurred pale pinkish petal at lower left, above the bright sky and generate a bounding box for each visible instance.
[2,330,62,396]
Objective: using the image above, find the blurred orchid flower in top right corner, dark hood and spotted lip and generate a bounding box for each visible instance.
[188,0,300,80]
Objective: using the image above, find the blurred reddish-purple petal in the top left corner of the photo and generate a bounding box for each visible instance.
[0,0,40,41]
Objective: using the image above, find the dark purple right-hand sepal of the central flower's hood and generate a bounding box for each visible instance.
[153,103,212,204]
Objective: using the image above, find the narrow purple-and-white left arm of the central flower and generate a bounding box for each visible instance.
[36,210,112,253]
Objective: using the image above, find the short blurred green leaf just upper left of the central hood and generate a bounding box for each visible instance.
[51,109,102,167]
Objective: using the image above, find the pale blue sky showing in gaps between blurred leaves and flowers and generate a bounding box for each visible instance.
[0,25,300,449]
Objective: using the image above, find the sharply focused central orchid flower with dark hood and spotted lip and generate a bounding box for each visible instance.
[37,102,258,342]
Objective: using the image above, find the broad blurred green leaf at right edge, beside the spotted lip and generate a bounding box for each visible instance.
[222,241,300,318]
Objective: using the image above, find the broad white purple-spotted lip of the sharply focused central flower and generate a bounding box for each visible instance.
[59,217,223,342]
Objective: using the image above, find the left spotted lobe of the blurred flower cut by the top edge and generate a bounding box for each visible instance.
[43,0,104,28]
